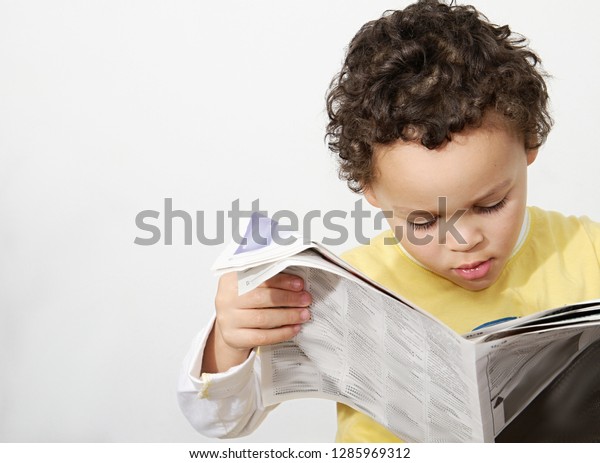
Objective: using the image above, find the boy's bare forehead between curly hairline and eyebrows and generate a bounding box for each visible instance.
[372,123,526,208]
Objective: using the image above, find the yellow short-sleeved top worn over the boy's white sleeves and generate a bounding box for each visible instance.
[336,207,600,442]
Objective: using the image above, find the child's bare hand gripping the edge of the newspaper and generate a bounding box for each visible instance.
[202,272,311,373]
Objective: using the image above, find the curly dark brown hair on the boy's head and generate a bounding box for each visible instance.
[326,0,552,192]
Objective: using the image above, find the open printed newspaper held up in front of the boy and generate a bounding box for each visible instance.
[213,216,600,442]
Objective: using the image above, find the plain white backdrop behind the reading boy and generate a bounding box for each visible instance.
[0,0,600,442]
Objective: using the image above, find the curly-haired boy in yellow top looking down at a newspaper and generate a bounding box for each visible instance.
[179,0,600,442]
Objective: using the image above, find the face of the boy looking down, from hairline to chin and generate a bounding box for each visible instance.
[365,114,537,291]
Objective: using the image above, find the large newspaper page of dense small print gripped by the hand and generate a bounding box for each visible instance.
[239,251,486,442]
